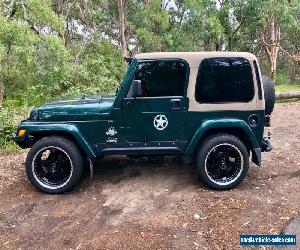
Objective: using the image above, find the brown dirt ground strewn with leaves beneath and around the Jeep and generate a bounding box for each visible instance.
[0,103,300,250]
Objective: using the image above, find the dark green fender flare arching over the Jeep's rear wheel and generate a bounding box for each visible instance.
[185,119,260,162]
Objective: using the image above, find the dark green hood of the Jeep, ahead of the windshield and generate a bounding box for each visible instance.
[29,95,115,121]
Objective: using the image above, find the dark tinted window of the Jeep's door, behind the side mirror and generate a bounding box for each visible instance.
[135,60,187,97]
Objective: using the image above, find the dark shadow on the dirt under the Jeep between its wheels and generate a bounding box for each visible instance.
[84,156,202,188]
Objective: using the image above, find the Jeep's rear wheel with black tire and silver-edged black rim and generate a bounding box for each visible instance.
[196,134,249,190]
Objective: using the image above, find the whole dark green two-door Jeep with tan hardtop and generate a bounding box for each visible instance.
[13,52,275,193]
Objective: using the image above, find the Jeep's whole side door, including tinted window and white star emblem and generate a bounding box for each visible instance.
[123,59,189,146]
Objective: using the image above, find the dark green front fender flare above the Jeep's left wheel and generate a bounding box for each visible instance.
[13,121,96,158]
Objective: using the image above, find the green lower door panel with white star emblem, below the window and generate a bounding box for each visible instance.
[123,97,188,142]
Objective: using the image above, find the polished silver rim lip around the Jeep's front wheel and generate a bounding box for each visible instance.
[31,146,73,190]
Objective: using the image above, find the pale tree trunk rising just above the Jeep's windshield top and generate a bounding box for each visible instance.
[117,0,128,57]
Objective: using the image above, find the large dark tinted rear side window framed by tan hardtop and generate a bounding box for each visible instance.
[195,58,254,103]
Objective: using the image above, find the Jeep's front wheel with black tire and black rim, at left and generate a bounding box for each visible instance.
[25,136,84,194]
